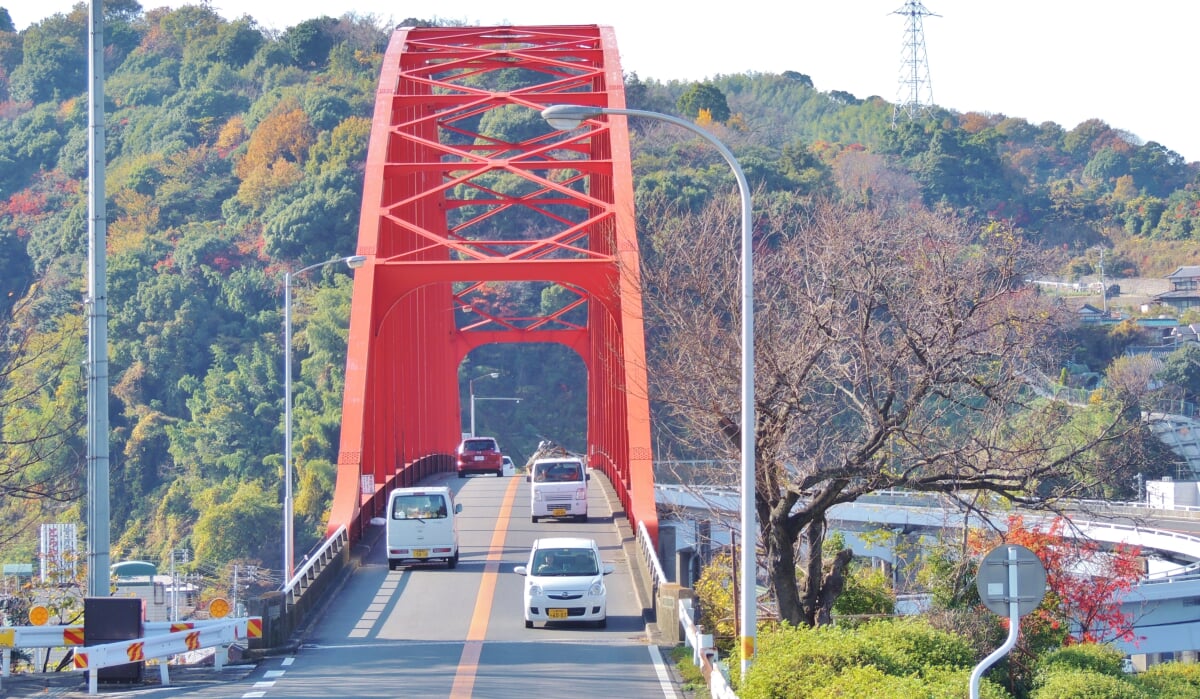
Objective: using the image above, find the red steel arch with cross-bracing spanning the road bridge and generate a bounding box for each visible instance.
[329,25,658,539]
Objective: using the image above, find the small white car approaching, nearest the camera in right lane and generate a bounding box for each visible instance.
[514,537,613,628]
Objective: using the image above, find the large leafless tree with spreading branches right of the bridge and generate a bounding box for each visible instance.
[642,197,1137,625]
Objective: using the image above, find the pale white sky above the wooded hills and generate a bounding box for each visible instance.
[9,0,1200,161]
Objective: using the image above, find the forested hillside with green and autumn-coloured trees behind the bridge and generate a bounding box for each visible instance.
[0,0,1200,598]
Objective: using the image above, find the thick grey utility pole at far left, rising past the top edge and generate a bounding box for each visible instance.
[85,0,112,597]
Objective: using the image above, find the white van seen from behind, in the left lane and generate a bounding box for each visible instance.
[388,486,462,570]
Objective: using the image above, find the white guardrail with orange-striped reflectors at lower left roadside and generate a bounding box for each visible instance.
[0,616,263,694]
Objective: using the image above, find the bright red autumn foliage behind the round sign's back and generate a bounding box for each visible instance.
[968,514,1142,644]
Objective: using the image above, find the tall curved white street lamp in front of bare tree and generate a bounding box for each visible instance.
[541,104,757,679]
